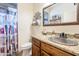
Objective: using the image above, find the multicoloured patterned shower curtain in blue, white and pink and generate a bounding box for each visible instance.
[0,7,18,56]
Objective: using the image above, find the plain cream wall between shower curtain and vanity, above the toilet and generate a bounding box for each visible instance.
[18,3,33,50]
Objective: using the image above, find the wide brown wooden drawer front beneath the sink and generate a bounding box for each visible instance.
[41,42,72,56]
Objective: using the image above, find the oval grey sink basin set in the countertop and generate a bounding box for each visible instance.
[48,37,78,46]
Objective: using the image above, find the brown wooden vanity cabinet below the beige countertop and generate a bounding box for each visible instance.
[32,38,74,56]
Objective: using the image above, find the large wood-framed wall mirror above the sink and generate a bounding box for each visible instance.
[43,3,79,26]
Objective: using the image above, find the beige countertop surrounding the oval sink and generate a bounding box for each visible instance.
[32,34,79,56]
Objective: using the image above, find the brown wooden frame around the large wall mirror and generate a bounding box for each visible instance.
[43,3,79,26]
